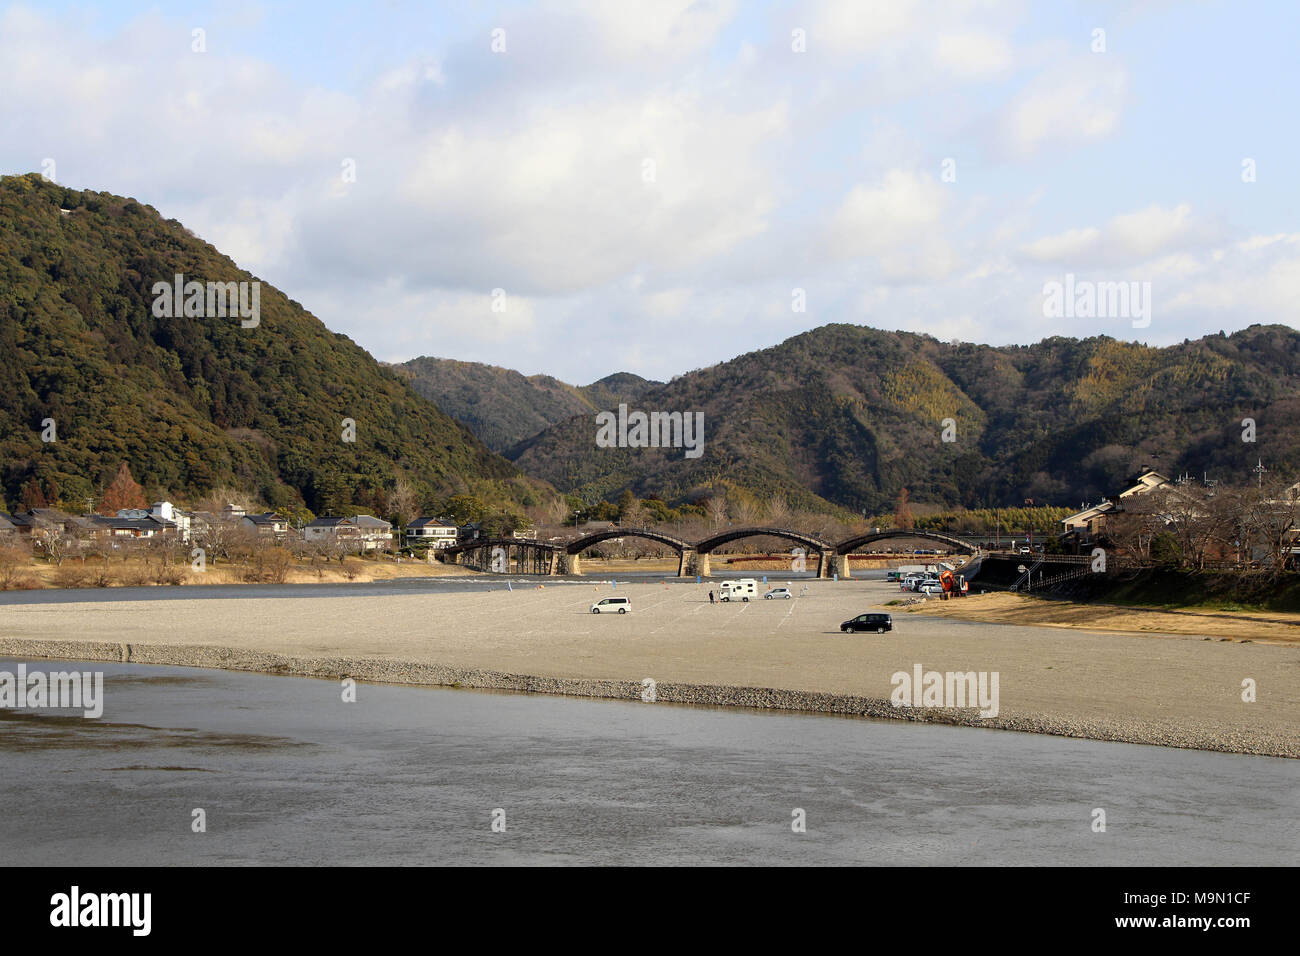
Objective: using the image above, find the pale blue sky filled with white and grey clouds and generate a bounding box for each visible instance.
[0,0,1300,384]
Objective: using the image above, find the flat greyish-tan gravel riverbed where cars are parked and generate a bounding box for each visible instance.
[0,579,1300,756]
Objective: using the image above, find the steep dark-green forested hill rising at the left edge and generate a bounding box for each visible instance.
[0,174,536,514]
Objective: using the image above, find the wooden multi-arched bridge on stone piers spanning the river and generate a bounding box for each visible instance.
[437,527,979,578]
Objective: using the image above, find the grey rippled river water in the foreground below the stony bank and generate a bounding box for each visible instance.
[0,658,1300,865]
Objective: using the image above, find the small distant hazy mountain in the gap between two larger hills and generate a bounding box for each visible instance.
[394,356,662,451]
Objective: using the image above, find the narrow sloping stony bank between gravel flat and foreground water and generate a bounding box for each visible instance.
[0,637,1300,757]
